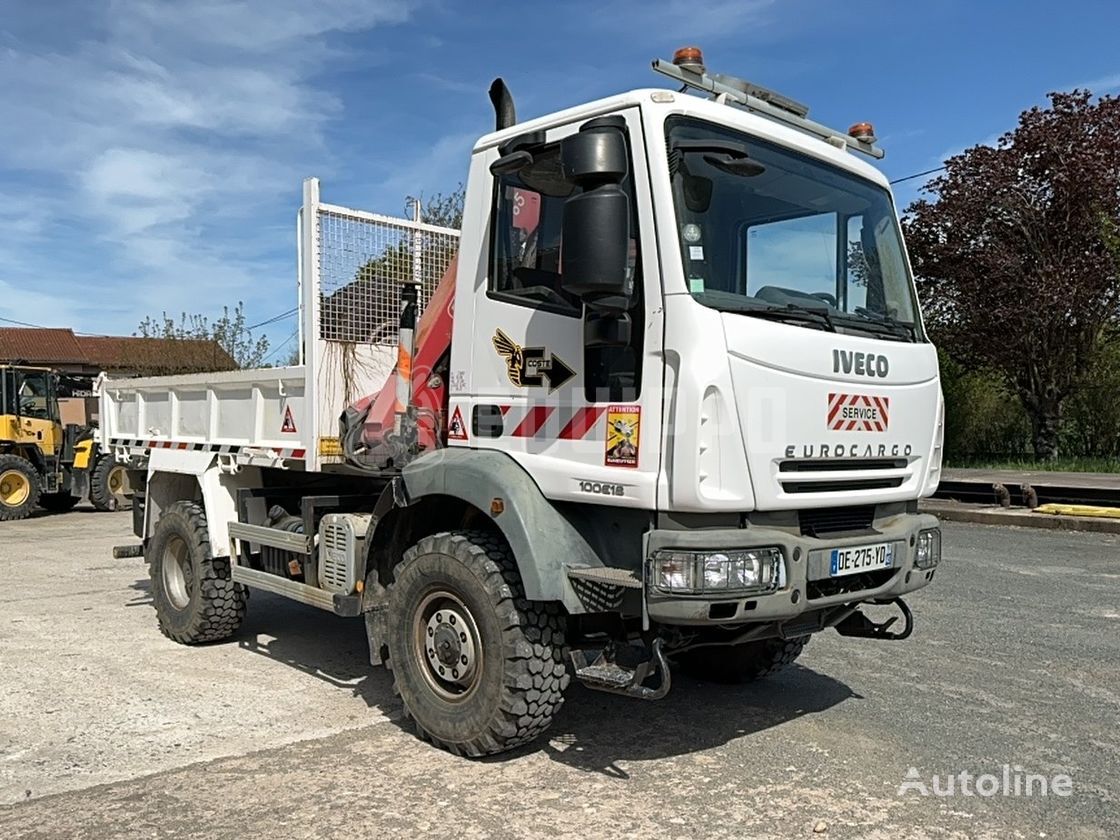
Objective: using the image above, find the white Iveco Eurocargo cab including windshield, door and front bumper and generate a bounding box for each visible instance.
[449,60,942,629]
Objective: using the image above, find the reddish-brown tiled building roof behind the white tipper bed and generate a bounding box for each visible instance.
[0,327,237,375]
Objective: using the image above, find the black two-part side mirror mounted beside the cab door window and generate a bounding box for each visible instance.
[560,116,634,311]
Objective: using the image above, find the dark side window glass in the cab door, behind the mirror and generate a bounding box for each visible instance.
[489,144,582,316]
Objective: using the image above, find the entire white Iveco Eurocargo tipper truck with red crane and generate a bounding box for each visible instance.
[102,48,942,756]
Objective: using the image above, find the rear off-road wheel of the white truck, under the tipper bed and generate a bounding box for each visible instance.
[146,502,249,644]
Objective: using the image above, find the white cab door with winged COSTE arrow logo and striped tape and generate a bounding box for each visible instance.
[450,106,663,508]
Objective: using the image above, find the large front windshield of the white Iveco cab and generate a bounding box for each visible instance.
[668,118,918,340]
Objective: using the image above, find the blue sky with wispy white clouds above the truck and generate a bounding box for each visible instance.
[0,0,1120,357]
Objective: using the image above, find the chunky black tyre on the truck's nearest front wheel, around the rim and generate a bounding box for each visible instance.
[386,531,570,757]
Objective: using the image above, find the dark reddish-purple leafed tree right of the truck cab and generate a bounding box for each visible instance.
[904,91,1120,459]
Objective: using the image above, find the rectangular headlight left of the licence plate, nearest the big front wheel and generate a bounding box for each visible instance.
[650,547,785,595]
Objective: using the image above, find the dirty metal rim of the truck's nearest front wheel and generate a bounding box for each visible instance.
[412,590,483,702]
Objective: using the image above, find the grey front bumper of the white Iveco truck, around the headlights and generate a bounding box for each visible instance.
[645,513,939,625]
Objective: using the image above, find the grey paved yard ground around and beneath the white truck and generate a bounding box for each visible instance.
[0,511,1120,838]
